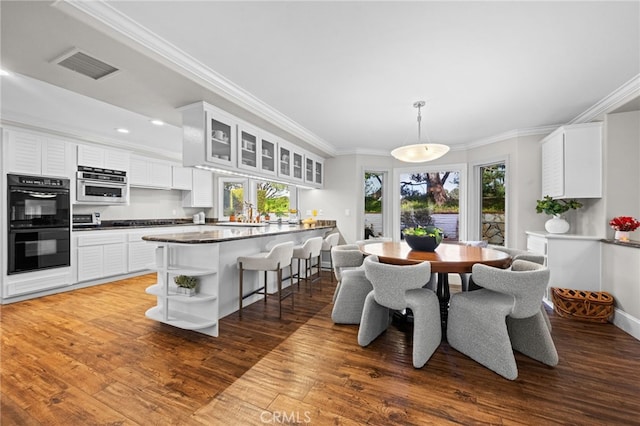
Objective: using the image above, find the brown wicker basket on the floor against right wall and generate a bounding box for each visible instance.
[551,287,613,323]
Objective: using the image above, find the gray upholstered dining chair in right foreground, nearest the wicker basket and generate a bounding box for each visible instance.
[447,259,558,380]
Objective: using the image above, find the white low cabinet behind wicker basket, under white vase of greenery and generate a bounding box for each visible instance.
[526,231,601,300]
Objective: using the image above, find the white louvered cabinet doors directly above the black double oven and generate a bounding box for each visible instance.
[5,130,75,178]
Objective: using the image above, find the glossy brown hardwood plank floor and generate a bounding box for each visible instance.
[0,275,640,425]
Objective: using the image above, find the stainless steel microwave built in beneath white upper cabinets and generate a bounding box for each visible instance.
[76,166,129,204]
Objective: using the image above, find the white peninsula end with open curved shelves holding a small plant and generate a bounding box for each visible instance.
[145,243,219,337]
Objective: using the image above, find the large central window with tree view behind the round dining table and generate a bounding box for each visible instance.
[398,169,462,240]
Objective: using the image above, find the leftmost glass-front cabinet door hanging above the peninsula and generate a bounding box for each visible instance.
[205,109,236,166]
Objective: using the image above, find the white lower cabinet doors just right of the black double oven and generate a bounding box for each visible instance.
[75,231,127,282]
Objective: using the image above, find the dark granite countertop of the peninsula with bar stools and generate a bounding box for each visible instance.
[142,224,335,244]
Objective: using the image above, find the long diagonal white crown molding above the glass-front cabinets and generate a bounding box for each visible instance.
[53,0,336,156]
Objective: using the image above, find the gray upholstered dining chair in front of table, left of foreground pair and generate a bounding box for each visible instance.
[358,256,442,368]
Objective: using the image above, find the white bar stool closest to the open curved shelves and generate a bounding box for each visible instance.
[238,241,293,318]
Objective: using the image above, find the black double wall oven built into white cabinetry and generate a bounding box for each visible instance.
[7,174,71,275]
